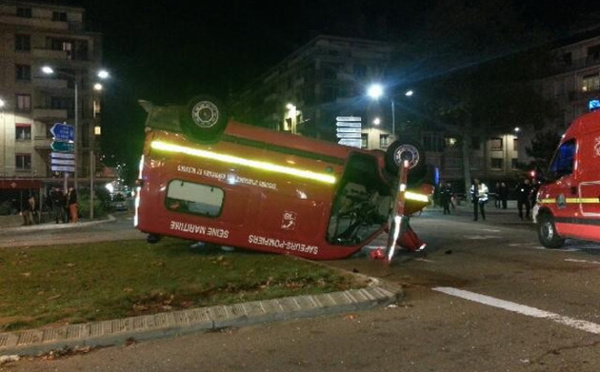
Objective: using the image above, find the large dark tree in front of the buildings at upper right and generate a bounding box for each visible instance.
[398,0,554,192]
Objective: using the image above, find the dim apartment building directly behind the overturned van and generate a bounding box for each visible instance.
[232,35,393,148]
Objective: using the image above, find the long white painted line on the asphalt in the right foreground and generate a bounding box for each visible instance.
[432,287,600,335]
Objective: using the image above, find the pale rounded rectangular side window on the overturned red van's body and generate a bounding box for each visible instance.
[165,180,225,217]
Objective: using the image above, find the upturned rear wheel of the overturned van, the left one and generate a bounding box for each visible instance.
[181,95,228,141]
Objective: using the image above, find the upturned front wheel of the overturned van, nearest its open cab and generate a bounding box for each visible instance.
[385,137,426,178]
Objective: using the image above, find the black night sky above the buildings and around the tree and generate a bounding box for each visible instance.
[56,0,600,176]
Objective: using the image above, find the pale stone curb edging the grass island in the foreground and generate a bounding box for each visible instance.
[0,286,403,356]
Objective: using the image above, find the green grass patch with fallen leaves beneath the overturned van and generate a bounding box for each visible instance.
[0,239,361,331]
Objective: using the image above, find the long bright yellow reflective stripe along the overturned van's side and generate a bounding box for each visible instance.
[150,141,336,184]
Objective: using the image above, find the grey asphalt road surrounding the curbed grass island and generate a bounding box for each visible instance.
[0,210,600,371]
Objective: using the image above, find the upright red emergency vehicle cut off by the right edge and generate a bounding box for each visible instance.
[534,111,600,248]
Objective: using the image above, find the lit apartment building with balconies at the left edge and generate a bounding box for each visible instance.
[0,0,102,203]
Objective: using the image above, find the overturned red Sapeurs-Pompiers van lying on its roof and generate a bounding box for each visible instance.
[135,98,431,260]
